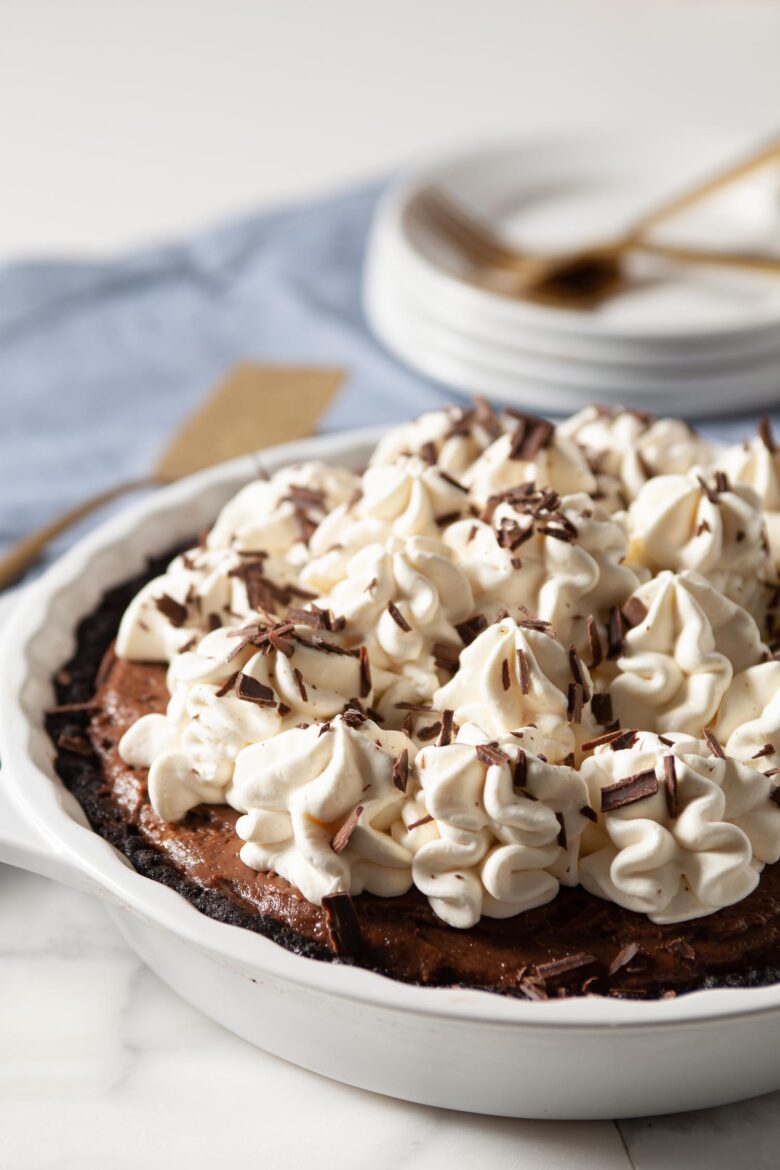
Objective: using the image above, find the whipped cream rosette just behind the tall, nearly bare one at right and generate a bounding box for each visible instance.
[627,469,769,612]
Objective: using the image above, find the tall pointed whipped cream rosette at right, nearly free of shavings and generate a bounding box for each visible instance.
[601,571,766,735]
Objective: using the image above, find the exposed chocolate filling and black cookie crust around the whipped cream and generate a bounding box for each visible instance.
[47,557,780,999]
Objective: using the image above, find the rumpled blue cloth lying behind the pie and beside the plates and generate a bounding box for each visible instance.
[0,187,776,575]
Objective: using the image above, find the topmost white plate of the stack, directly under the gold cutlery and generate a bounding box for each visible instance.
[370,130,780,360]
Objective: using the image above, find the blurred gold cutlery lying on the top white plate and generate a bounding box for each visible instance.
[418,138,780,309]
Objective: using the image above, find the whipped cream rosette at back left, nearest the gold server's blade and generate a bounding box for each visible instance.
[207,462,359,557]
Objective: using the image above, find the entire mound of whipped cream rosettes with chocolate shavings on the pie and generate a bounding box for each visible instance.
[116,402,780,928]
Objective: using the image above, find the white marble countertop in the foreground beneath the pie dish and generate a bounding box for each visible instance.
[0,599,780,1170]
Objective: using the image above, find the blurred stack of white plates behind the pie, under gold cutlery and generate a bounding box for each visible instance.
[364,132,780,415]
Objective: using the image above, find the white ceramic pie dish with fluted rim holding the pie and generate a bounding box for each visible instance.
[0,431,780,1119]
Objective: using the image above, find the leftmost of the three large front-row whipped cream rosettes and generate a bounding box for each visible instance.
[229,713,415,904]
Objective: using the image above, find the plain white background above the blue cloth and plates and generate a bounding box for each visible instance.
[0,0,780,261]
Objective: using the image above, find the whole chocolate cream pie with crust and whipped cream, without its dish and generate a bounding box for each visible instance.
[49,401,780,999]
